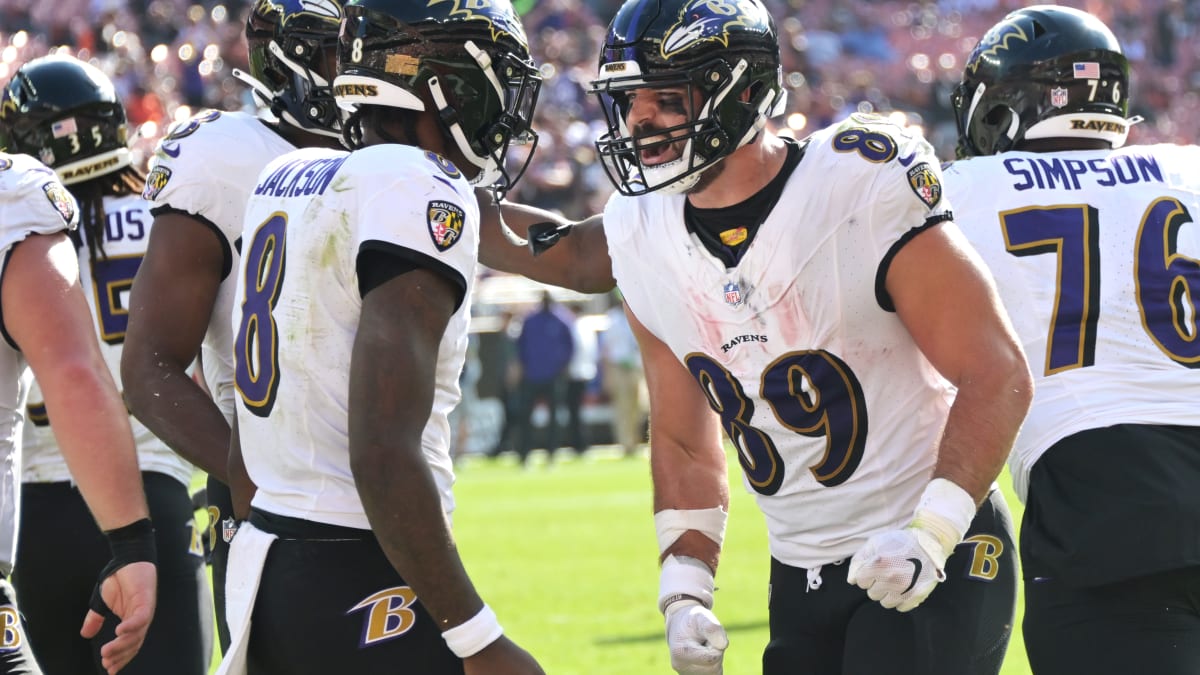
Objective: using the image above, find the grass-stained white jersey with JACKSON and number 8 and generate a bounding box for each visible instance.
[233,144,479,528]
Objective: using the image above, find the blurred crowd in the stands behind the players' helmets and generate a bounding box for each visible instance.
[0,0,1200,217]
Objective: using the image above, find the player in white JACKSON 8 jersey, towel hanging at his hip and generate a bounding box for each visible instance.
[221,0,542,675]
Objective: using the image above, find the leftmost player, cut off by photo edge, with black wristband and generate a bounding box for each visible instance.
[0,156,156,675]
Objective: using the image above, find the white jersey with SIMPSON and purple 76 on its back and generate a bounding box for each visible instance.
[946,145,1200,500]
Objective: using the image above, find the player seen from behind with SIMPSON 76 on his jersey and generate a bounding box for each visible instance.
[946,6,1200,675]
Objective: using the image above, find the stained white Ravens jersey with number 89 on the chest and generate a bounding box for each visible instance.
[604,115,953,568]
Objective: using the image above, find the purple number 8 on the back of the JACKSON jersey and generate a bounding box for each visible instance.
[233,213,288,417]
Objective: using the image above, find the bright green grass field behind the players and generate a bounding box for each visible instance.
[204,448,1030,675]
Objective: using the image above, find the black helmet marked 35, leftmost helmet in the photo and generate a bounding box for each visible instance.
[0,55,132,185]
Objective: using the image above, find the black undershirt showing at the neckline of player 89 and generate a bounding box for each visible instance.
[683,138,808,267]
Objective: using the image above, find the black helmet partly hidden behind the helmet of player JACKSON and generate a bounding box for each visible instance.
[234,0,342,137]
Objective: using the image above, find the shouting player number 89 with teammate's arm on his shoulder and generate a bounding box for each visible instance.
[481,0,1032,675]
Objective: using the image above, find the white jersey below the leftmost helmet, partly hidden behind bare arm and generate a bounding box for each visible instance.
[22,195,193,485]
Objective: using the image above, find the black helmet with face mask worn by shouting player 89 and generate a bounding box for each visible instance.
[588,0,787,195]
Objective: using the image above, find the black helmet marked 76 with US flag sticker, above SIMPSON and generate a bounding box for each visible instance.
[950,5,1132,159]
